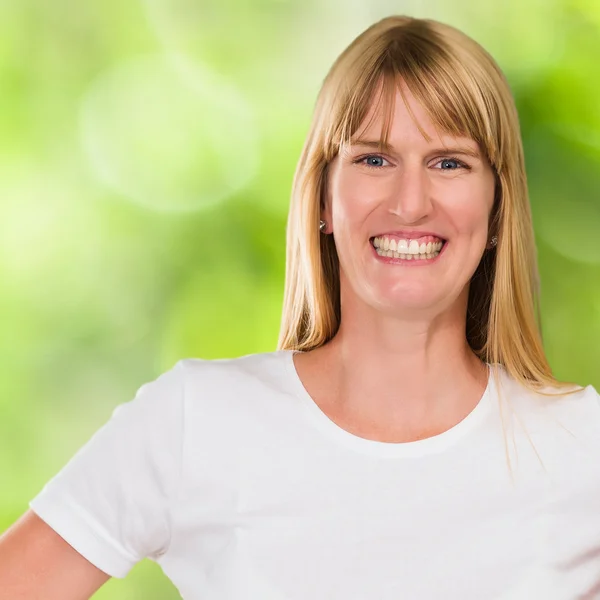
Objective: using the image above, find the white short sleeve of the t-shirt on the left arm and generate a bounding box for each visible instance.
[29,361,184,578]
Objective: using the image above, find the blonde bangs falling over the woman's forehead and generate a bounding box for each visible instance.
[322,28,501,172]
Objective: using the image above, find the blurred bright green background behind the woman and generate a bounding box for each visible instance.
[0,0,600,600]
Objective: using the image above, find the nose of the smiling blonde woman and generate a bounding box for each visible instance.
[389,165,433,224]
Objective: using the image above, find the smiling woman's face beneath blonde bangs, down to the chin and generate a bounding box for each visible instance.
[322,87,495,314]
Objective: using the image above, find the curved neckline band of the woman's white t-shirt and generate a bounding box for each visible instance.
[280,350,496,457]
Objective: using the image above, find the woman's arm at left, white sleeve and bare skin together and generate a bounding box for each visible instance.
[0,358,183,600]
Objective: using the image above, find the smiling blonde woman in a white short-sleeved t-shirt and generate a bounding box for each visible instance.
[0,17,600,600]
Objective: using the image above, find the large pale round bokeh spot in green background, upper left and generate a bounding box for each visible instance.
[80,55,258,212]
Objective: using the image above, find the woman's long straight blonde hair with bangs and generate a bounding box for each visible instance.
[278,16,581,404]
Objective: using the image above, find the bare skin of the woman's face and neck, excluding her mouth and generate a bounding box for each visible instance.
[294,84,495,442]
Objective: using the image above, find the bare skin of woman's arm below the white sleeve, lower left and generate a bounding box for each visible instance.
[0,510,110,600]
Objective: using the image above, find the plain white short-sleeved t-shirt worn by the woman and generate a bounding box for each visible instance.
[30,350,600,600]
